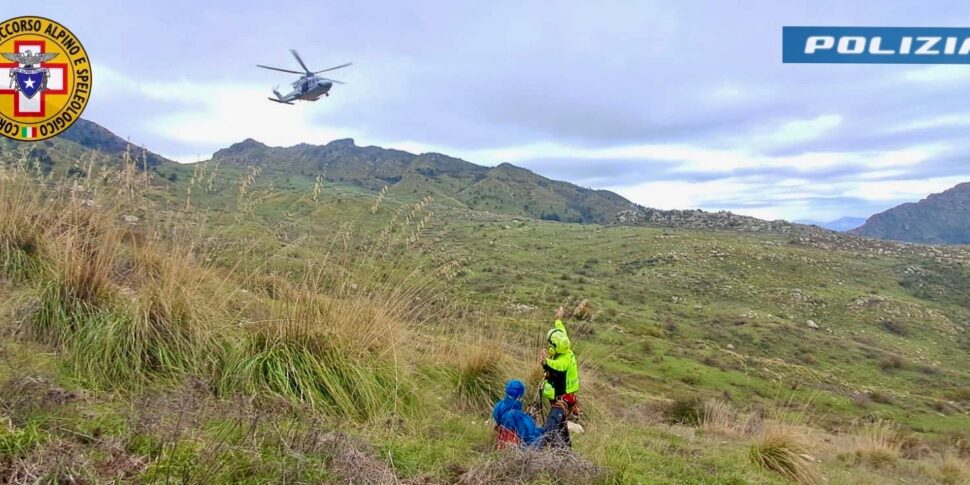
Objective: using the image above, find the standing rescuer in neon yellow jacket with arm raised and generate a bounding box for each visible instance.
[539,307,579,446]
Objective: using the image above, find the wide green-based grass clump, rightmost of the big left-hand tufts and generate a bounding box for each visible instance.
[219,282,412,421]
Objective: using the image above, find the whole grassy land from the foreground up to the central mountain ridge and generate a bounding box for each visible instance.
[0,125,970,484]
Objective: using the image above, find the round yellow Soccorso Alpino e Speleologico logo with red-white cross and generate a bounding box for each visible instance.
[0,17,91,141]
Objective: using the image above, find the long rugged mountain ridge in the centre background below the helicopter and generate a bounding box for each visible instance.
[212,134,635,223]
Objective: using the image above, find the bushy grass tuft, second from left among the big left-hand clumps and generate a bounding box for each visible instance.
[65,246,229,383]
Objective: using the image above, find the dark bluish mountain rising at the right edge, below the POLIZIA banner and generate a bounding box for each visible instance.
[852,182,970,244]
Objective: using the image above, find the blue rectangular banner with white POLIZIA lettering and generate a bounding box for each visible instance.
[782,27,970,64]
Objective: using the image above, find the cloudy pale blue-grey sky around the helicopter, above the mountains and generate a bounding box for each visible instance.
[11,0,970,220]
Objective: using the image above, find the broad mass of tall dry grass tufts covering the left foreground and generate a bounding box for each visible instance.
[0,148,440,420]
